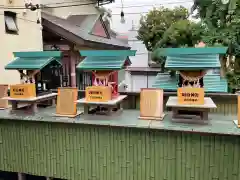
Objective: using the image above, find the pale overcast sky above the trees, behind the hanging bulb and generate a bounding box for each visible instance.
[105,0,193,33]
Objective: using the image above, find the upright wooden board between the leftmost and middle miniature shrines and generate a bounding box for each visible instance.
[56,87,78,116]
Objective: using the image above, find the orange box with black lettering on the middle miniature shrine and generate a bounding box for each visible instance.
[85,86,112,102]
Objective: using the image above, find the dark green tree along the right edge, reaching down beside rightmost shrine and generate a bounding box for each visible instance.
[192,0,240,90]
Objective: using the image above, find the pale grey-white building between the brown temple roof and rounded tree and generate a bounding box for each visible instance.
[117,21,160,92]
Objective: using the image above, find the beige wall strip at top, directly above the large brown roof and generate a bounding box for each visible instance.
[41,0,99,18]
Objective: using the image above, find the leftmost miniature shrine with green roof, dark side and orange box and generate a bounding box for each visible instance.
[3,51,61,112]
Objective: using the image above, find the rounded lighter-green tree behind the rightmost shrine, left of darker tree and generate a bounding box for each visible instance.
[137,6,203,68]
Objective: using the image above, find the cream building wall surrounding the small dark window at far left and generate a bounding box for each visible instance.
[0,0,42,84]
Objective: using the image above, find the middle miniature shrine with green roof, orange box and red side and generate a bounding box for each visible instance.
[77,50,136,114]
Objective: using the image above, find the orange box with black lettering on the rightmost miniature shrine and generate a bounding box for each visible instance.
[177,87,204,105]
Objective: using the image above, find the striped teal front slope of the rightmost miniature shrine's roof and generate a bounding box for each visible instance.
[165,54,221,70]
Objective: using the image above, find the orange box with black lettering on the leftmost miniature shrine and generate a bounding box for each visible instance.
[10,84,36,99]
